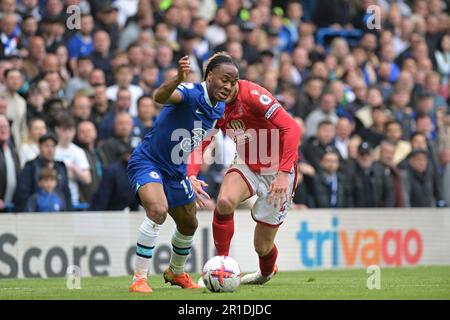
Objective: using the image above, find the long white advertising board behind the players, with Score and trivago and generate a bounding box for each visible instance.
[0,208,450,278]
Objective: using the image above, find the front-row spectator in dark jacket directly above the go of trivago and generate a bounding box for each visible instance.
[401,149,445,207]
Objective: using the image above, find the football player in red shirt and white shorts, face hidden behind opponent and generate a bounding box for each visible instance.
[188,80,301,284]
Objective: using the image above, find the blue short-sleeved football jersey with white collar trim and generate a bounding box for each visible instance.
[135,82,225,179]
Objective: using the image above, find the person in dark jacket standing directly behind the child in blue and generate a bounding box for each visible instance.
[14,133,71,212]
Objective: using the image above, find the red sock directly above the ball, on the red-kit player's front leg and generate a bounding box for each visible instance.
[213,209,234,256]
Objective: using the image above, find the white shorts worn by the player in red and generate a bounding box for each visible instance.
[227,162,297,227]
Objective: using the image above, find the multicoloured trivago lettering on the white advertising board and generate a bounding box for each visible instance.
[297,217,423,268]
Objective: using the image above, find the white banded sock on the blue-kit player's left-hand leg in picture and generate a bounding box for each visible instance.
[134,217,161,277]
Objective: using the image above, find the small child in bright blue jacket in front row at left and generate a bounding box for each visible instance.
[25,168,67,213]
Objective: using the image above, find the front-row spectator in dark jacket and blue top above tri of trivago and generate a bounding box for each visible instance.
[313,149,349,208]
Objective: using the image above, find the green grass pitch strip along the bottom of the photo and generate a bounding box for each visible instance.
[0,266,450,300]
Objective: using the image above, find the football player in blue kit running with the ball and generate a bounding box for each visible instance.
[128,52,239,293]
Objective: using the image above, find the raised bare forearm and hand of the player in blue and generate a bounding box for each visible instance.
[153,56,191,104]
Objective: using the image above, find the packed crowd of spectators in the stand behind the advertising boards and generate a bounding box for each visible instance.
[0,0,450,212]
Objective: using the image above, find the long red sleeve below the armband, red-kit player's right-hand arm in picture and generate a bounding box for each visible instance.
[268,108,302,172]
